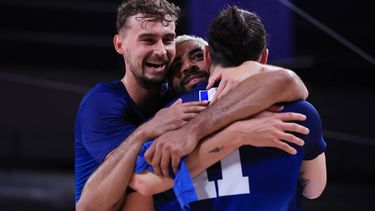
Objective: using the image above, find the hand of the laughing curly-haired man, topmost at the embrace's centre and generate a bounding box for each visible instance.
[143,99,208,138]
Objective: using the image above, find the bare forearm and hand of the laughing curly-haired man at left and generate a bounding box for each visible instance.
[76,100,207,211]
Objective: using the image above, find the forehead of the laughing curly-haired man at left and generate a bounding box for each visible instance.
[125,13,176,34]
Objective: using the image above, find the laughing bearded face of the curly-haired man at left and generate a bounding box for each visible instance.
[115,14,176,86]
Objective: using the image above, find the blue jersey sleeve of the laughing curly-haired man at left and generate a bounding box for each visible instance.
[79,92,136,163]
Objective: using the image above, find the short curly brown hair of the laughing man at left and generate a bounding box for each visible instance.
[116,0,180,32]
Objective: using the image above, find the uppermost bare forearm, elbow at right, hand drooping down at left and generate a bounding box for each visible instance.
[146,69,307,176]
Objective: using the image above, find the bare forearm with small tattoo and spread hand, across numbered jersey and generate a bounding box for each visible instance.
[129,111,309,195]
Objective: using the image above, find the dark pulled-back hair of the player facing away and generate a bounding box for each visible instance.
[208,6,266,67]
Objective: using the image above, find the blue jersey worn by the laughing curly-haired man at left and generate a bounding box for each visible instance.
[75,81,154,202]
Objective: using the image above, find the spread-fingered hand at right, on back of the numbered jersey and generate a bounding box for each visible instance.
[228,111,309,155]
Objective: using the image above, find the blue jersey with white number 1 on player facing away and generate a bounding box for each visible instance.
[154,83,326,211]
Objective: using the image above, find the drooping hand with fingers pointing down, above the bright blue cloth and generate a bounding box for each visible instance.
[145,127,199,177]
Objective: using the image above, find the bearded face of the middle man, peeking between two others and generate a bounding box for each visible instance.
[169,40,209,94]
